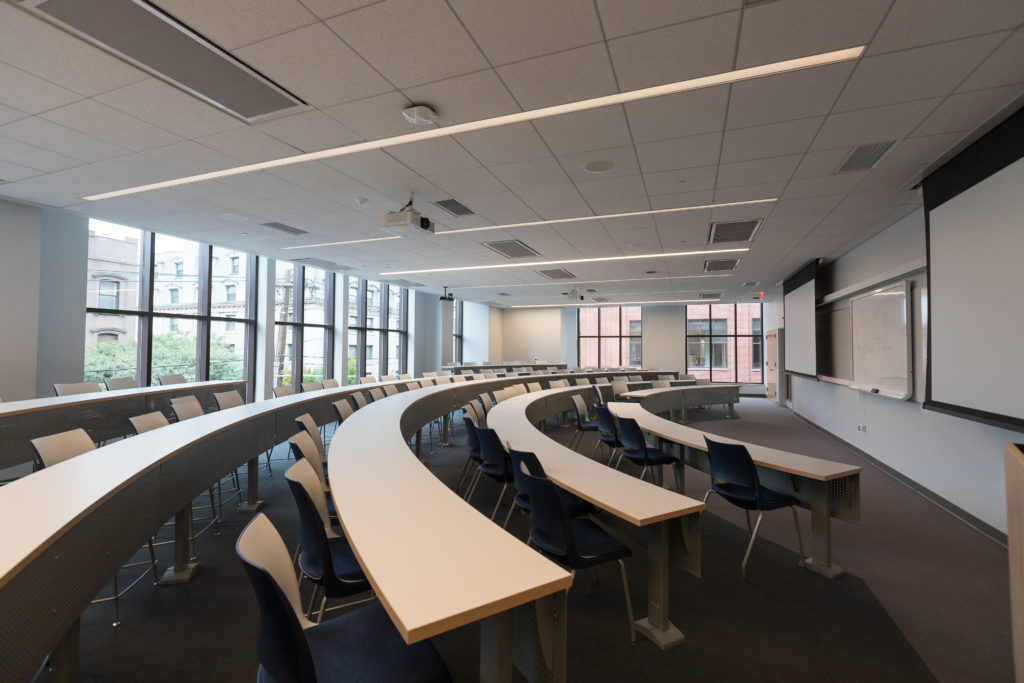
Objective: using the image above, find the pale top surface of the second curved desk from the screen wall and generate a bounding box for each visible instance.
[487,387,705,526]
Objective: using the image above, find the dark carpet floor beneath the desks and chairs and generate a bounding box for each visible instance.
[40,398,1013,682]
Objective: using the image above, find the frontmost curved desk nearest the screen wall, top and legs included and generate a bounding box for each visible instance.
[608,402,861,578]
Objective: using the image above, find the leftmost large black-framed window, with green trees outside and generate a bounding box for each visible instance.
[85,214,256,391]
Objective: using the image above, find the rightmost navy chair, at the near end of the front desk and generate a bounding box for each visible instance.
[703,436,805,579]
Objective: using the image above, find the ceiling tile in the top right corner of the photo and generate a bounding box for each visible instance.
[868,0,1024,54]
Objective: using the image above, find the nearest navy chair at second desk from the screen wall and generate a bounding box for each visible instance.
[520,472,637,643]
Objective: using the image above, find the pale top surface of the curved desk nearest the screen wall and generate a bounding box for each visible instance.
[608,401,861,481]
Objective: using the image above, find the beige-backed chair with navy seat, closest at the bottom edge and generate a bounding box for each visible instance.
[234,513,452,683]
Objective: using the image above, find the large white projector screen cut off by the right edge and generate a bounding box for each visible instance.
[929,159,1024,425]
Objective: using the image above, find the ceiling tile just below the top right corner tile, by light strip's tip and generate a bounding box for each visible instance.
[836,34,1006,112]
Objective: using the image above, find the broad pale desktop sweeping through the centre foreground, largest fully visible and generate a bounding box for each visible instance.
[328,383,571,643]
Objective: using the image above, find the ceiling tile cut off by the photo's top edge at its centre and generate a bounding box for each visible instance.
[449,0,603,65]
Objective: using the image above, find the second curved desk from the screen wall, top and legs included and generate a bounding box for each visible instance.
[487,387,705,649]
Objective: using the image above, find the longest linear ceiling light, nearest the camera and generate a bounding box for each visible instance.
[82,45,865,202]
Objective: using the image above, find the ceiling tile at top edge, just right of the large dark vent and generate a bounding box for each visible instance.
[154,0,316,50]
